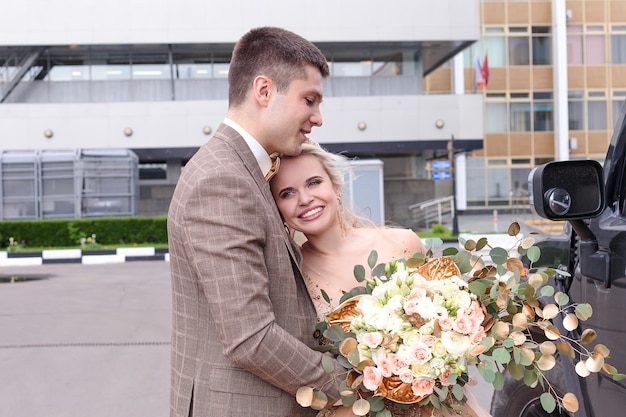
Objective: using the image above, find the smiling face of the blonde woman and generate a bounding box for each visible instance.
[271,154,340,235]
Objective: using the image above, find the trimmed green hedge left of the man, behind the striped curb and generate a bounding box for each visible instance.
[0,216,167,248]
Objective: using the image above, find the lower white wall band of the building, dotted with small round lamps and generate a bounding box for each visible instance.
[0,95,483,150]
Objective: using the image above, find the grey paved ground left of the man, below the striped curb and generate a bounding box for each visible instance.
[0,261,171,417]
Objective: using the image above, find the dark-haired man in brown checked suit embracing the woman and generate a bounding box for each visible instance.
[167,27,342,417]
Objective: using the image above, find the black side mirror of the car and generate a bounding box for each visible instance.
[528,160,605,220]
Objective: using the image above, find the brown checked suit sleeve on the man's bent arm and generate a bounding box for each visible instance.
[178,168,343,402]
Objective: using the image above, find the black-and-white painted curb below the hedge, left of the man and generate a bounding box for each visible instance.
[0,247,170,267]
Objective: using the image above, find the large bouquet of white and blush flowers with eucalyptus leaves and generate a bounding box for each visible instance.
[296,223,626,417]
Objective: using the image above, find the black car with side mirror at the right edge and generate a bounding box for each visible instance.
[491,106,626,417]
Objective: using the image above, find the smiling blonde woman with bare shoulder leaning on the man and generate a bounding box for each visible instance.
[270,142,489,417]
